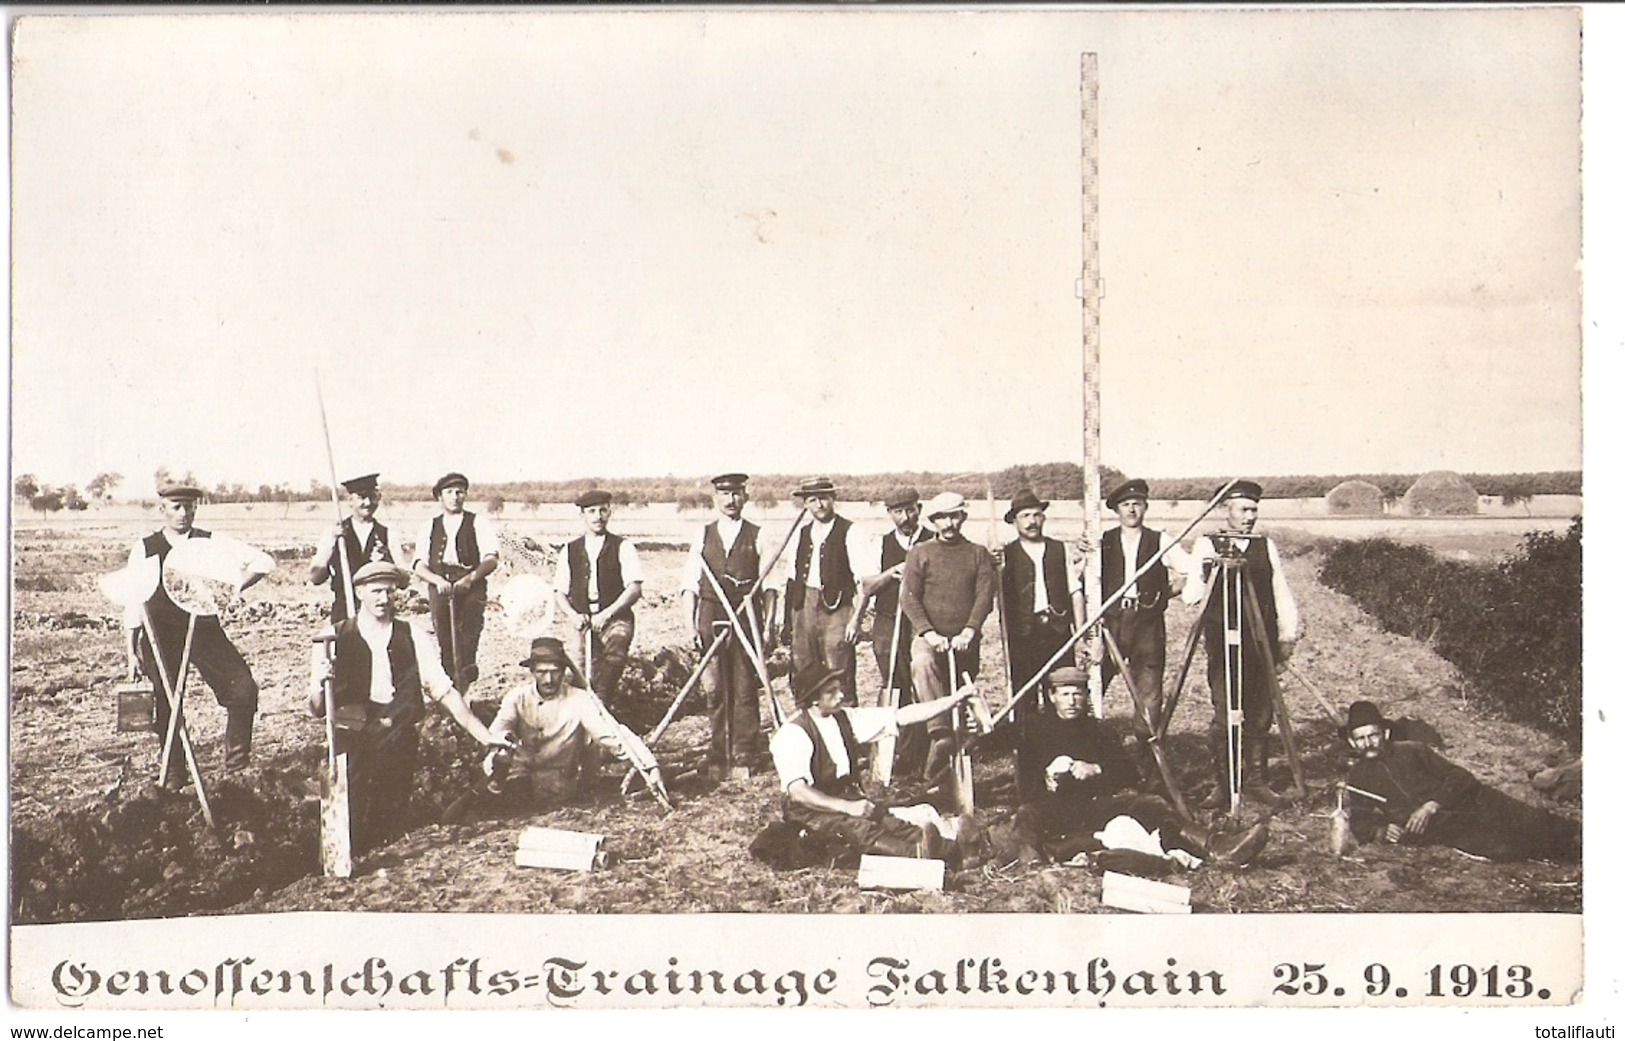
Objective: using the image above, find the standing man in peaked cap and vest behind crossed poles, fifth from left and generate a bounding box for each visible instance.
[679,474,778,780]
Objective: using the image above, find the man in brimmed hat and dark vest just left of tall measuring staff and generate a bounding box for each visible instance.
[1001,489,1084,716]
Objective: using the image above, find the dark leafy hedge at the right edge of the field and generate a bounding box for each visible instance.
[1320,518,1583,749]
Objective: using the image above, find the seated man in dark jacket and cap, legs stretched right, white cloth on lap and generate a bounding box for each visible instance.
[977,667,1269,874]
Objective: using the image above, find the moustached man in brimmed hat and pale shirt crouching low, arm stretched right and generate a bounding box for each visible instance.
[440,637,660,823]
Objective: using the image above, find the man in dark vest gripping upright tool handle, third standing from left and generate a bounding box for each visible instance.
[413,473,501,693]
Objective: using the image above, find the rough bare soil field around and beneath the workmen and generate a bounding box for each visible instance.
[10,503,1581,922]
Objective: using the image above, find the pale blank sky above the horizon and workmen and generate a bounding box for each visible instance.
[11,10,1581,494]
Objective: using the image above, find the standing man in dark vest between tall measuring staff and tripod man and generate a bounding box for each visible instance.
[1100,477,1190,778]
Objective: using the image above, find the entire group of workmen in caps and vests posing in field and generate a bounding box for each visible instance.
[127,473,1578,866]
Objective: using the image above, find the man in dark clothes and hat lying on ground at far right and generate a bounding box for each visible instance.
[1342,702,1580,862]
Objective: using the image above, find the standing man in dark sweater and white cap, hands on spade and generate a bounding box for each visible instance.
[902,492,998,778]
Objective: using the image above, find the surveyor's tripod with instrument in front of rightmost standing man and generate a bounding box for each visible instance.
[1155,531,1308,814]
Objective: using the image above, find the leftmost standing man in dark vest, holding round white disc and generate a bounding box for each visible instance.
[124,482,276,773]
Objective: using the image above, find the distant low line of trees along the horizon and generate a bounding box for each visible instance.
[11,463,1583,513]
